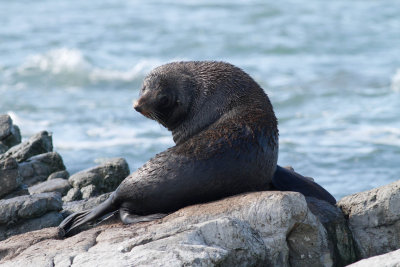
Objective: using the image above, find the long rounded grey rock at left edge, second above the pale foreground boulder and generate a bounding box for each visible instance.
[0,192,62,226]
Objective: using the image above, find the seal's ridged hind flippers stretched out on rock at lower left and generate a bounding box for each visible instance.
[58,194,118,236]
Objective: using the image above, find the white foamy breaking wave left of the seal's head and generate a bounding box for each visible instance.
[10,48,162,87]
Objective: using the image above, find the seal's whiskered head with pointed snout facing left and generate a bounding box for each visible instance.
[133,66,196,131]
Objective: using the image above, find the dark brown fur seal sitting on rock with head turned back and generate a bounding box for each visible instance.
[59,61,335,237]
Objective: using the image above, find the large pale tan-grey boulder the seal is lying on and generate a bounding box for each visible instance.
[0,192,334,266]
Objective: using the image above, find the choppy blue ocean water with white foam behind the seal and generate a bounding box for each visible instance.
[0,0,400,201]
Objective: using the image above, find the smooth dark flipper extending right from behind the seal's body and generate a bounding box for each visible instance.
[272,166,336,205]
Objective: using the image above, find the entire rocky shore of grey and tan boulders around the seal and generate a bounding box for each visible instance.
[0,115,400,266]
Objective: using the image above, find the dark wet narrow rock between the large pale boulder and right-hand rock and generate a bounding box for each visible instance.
[306,197,357,266]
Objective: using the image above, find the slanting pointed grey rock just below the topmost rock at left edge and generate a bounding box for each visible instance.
[0,131,53,162]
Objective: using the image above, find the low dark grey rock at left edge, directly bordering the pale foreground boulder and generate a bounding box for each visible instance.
[0,211,63,243]
